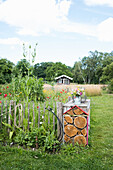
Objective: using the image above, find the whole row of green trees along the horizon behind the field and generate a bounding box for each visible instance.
[0,51,113,84]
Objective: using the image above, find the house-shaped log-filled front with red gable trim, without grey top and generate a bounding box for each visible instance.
[63,105,89,145]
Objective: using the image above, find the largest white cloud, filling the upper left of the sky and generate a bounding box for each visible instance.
[0,0,71,35]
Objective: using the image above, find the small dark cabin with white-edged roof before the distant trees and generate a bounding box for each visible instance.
[55,75,73,85]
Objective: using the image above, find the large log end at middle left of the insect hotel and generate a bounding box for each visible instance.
[64,125,77,137]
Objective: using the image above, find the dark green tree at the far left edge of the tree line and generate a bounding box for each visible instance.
[0,59,14,84]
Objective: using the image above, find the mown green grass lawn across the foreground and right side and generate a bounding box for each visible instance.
[0,94,113,170]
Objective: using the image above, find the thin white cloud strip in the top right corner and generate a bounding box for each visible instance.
[84,0,113,7]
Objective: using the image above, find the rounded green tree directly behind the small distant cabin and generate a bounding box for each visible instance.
[46,62,73,81]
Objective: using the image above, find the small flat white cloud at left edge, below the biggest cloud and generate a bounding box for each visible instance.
[0,38,24,45]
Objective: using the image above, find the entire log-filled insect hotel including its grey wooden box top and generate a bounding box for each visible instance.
[63,99,90,146]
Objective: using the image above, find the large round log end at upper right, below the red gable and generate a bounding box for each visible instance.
[74,117,86,129]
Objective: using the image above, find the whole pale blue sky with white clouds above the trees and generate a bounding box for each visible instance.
[0,0,113,67]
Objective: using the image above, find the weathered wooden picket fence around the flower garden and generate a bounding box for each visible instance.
[0,100,62,135]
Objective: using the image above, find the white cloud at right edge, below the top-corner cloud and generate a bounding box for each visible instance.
[97,17,113,42]
